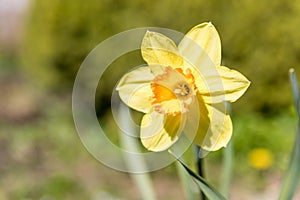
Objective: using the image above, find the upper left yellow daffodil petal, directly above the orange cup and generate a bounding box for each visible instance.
[141,31,183,75]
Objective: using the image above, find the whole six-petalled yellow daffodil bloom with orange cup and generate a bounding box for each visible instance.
[117,23,250,151]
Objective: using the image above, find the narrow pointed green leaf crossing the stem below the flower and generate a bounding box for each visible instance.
[179,160,226,200]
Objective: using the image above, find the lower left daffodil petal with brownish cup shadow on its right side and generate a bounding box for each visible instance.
[141,111,185,152]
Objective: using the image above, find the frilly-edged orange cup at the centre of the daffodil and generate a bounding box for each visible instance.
[151,67,197,115]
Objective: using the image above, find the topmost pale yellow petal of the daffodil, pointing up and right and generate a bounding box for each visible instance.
[178,22,221,66]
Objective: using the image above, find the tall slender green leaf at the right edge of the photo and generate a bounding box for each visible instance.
[279,69,300,200]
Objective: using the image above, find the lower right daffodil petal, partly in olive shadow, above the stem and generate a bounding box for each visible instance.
[186,93,232,151]
